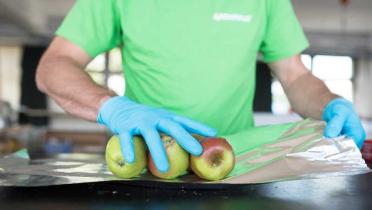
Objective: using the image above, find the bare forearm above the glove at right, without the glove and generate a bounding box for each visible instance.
[269,55,339,119]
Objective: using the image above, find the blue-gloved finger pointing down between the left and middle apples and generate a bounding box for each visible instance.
[141,128,169,172]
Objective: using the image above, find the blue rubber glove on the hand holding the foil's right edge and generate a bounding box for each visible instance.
[323,98,366,149]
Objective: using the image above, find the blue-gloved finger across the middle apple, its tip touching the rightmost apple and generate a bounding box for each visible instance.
[158,120,203,156]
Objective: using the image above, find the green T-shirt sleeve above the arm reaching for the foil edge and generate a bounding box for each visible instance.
[260,0,309,62]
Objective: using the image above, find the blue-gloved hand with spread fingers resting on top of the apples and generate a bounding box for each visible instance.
[97,96,216,172]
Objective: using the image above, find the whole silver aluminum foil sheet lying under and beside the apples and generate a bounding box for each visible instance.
[0,120,370,187]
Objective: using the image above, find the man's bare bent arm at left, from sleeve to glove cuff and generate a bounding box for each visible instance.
[36,37,115,121]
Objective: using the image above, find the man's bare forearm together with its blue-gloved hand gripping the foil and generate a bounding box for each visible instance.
[269,55,366,149]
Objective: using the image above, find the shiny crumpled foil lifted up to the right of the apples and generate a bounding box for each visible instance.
[222,120,370,184]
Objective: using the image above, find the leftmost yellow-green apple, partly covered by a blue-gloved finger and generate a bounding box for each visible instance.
[105,136,147,179]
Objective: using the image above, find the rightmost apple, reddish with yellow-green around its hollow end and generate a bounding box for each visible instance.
[190,136,235,181]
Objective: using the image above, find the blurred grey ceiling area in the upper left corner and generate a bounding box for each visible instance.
[0,0,75,43]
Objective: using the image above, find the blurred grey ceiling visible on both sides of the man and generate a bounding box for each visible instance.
[0,0,372,55]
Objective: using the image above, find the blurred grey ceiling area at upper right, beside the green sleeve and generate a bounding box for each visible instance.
[292,0,372,57]
